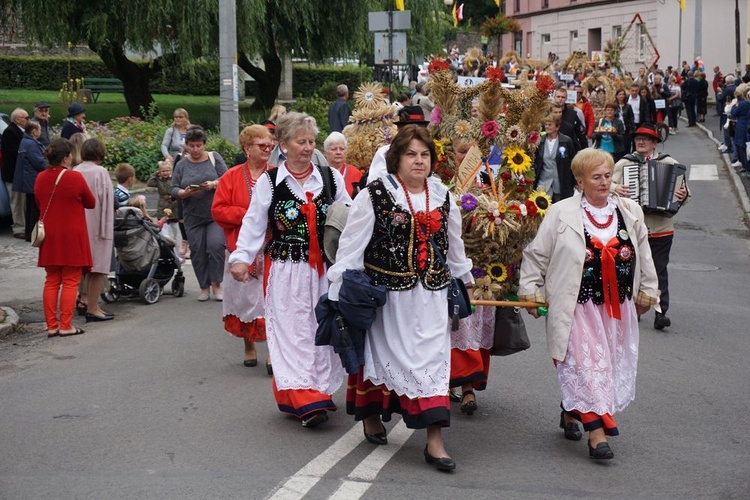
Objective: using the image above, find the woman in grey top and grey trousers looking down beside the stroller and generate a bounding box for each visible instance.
[172,128,227,302]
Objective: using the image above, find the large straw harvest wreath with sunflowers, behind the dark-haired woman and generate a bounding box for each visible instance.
[428,58,552,300]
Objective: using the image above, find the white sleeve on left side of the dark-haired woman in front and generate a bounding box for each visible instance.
[328,191,375,300]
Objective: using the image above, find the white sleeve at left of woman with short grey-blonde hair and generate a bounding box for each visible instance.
[229,175,273,265]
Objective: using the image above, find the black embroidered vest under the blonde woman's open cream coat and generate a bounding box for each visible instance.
[578,208,636,305]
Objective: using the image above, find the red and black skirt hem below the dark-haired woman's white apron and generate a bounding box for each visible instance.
[346,367,450,429]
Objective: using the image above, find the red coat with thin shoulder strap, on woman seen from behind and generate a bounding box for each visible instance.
[34,167,96,268]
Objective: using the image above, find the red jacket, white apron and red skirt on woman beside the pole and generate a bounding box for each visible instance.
[211,163,268,342]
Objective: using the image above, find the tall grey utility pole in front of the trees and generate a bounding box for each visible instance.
[219,0,240,144]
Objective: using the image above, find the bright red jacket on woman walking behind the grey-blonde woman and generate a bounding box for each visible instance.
[211,163,274,252]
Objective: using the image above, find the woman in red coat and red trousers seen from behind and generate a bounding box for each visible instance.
[34,139,95,337]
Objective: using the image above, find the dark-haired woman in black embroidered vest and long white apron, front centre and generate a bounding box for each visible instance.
[328,125,473,471]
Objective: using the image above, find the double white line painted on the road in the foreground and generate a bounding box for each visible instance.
[270,420,414,500]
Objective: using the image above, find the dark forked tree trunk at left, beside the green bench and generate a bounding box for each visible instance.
[89,44,160,119]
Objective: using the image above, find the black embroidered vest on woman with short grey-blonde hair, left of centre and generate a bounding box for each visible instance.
[265,167,336,262]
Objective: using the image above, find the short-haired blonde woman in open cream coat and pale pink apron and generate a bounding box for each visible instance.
[518,148,659,459]
